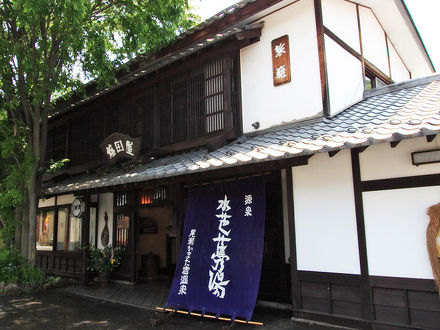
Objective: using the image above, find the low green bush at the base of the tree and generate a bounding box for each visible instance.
[0,249,44,288]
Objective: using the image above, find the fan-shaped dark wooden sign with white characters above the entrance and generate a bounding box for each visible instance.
[99,133,141,163]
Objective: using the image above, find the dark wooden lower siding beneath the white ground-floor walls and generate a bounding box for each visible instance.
[295,271,440,329]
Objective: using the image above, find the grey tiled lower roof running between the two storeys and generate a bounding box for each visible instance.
[44,75,440,194]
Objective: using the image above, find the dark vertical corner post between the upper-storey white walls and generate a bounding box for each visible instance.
[314,0,330,118]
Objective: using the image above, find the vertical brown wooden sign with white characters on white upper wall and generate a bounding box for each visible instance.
[272,34,290,86]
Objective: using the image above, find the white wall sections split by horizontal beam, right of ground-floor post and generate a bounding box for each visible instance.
[359,136,440,279]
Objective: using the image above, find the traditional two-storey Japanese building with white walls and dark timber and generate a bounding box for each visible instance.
[37,0,440,329]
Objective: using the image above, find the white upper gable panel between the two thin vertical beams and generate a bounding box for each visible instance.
[359,7,390,75]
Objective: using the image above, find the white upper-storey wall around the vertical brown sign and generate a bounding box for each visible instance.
[240,0,322,133]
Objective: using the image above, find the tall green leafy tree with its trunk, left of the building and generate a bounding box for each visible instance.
[0,0,193,261]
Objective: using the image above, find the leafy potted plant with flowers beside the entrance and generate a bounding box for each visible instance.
[87,244,124,273]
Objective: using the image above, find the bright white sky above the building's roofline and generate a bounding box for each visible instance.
[190,0,440,72]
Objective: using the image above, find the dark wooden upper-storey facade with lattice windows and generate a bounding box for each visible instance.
[46,57,241,166]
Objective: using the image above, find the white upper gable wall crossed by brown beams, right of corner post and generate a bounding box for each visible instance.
[322,0,410,115]
